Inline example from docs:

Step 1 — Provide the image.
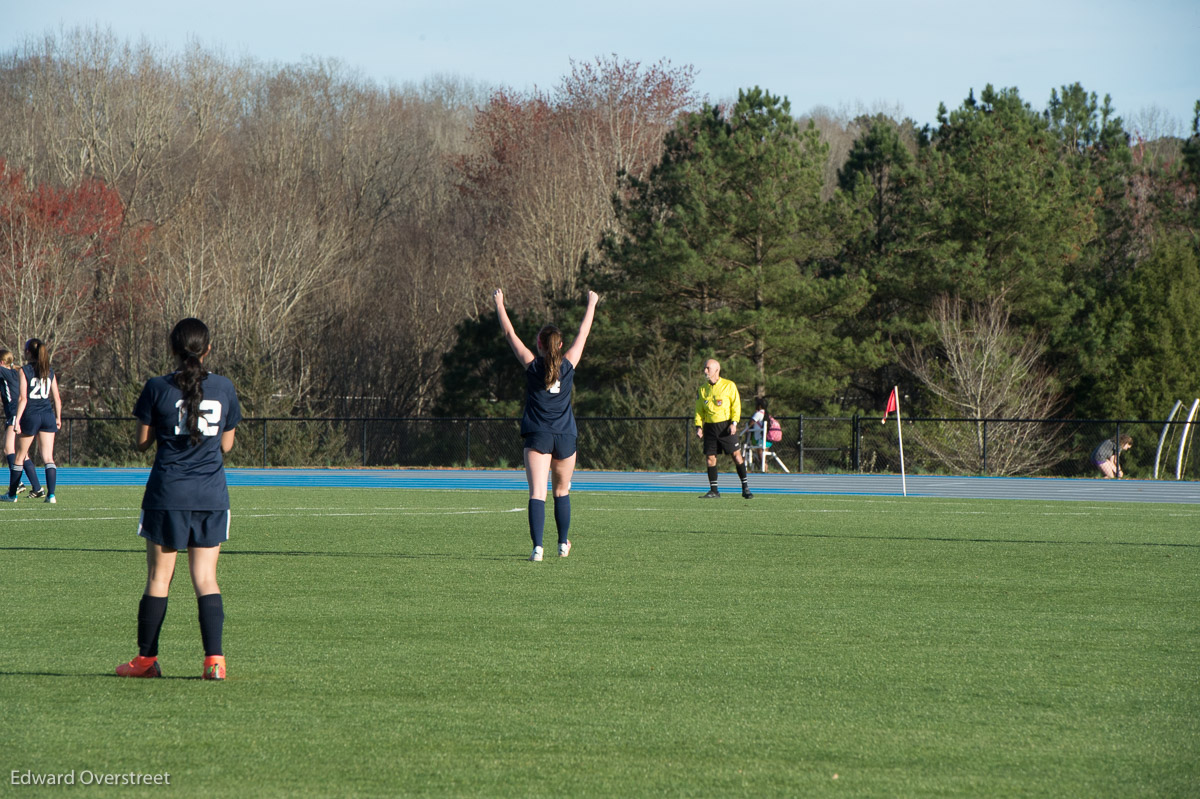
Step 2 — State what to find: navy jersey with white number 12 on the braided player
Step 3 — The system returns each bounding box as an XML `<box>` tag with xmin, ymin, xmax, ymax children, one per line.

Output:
<box><xmin>133</xmin><ymin>374</ymin><xmax>241</xmax><ymax>510</ymax></box>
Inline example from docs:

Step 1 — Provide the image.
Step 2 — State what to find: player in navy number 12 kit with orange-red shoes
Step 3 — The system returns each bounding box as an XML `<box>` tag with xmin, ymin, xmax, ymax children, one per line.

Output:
<box><xmin>116</xmin><ymin>318</ymin><xmax>241</xmax><ymax>680</ymax></box>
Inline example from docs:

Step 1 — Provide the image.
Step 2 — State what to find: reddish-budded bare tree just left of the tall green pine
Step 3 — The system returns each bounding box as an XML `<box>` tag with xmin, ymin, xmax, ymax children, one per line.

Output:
<box><xmin>461</xmin><ymin>56</ymin><xmax>696</xmax><ymax>307</ymax></box>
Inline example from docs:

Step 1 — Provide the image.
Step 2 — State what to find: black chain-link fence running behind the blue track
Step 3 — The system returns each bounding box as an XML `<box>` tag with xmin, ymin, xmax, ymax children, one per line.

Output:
<box><xmin>55</xmin><ymin>416</ymin><xmax>1200</xmax><ymax>480</ymax></box>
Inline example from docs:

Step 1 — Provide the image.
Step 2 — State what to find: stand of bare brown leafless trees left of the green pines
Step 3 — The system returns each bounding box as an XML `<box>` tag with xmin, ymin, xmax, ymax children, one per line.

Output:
<box><xmin>0</xmin><ymin>36</ymin><xmax>695</xmax><ymax>422</ymax></box>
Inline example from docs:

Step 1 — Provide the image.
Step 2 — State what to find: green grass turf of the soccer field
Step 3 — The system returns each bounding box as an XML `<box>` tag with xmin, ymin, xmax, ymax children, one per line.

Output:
<box><xmin>0</xmin><ymin>487</ymin><xmax>1200</xmax><ymax>797</ymax></box>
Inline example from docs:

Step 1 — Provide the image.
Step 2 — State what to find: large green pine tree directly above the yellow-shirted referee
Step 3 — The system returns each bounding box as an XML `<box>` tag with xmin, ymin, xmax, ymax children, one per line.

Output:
<box><xmin>605</xmin><ymin>88</ymin><xmax>868</xmax><ymax>407</ymax></box>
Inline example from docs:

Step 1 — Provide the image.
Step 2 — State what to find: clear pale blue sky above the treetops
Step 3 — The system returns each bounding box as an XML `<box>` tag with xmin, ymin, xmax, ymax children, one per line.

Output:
<box><xmin>0</xmin><ymin>0</ymin><xmax>1200</xmax><ymax>132</ymax></box>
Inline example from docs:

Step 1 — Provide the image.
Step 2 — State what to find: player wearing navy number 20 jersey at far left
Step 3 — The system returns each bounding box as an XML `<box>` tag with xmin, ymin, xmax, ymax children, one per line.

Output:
<box><xmin>0</xmin><ymin>338</ymin><xmax>62</xmax><ymax>505</ymax></box>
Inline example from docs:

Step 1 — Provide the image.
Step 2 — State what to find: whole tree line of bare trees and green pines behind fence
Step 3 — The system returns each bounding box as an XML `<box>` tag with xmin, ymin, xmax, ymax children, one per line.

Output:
<box><xmin>0</xmin><ymin>29</ymin><xmax>1200</xmax><ymax>447</ymax></box>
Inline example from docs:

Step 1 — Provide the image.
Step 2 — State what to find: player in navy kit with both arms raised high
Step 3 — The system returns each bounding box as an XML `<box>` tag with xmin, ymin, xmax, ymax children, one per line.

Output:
<box><xmin>493</xmin><ymin>289</ymin><xmax>600</xmax><ymax>560</ymax></box>
